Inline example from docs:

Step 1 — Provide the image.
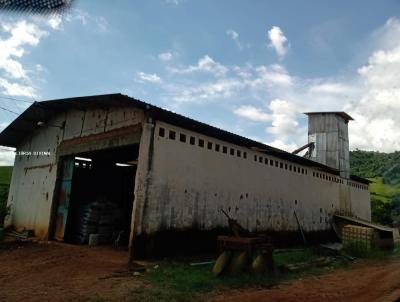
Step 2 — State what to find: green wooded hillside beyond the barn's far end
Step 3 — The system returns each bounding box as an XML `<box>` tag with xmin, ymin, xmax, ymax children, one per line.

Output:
<box><xmin>350</xmin><ymin>150</ymin><xmax>400</xmax><ymax>225</ymax></box>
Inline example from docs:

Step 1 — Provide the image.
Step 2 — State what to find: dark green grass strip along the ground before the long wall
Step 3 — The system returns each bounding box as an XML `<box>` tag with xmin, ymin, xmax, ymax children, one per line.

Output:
<box><xmin>130</xmin><ymin>249</ymin><xmax>338</xmax><ymax>302</ymax></box>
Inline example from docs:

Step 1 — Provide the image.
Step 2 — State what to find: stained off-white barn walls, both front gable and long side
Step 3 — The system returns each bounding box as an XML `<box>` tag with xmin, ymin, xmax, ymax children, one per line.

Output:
<box><xmin>8</xmin><ymin>108</ymin><xmax>371</xmax><ymax>238</ymax></box>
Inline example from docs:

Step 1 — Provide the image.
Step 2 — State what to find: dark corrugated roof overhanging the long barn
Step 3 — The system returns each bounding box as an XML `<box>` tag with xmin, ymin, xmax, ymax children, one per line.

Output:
<box><xmin>0</xmin><ymin>93</ymin><xmax>369</xmax><ymax>183</ymax></box>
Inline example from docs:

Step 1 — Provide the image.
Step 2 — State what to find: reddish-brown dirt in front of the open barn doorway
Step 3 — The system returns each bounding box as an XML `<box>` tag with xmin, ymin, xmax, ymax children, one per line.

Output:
<box><xmin>0</xmin><ymin>242</ymin><xmax>145</xmax><ymax>302</ymax></box>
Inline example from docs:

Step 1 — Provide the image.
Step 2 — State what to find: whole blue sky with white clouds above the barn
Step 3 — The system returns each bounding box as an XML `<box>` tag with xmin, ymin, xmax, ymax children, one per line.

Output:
<box><xmin>0</xmin><ymin>0</ymin><xmax>400</xmax><ymax>165</ymax></box>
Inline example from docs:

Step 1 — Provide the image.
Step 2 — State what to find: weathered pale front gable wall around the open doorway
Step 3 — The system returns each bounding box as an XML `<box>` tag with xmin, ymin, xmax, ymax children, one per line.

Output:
<box><xmin>7</xmin><ymin>108</ymin><xmax>144</xmax><ymax>238</ymax></box>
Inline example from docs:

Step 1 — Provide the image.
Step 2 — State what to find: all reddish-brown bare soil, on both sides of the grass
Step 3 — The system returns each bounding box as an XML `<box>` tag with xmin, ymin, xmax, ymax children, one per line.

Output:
<box><xmin>0</xmin><ymin>242</ymin><xmax>400</xmax><ymax>302</ymax></box>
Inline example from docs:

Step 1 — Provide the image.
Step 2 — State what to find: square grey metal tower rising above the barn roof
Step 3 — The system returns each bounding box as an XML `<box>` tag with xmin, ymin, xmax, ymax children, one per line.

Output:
<box><xmin>306</xmin><ymin>112</ymin><xmax>353</xmax><ymax>179</ymax></box>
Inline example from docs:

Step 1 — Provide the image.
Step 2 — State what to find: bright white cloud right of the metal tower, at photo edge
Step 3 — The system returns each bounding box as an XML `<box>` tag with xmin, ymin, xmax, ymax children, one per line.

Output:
<box><xmin>345</xmin><ymin>18</ymin><xmax>400</xmax><ymax>151</ymax></box>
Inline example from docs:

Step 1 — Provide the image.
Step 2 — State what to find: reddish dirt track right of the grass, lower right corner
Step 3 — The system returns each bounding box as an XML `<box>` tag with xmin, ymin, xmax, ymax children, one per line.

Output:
<box><xmin>210</xmin><ymin>259</ymin><xmax>400</xmax><ymax>302</ymax></box>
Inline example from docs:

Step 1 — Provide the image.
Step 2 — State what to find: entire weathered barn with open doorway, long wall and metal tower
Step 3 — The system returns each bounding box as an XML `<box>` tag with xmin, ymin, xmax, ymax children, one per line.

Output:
<box><xmin>0</xmin><ymin>94</ymin><xmax>371</xmax><ymax>255</ymax></box>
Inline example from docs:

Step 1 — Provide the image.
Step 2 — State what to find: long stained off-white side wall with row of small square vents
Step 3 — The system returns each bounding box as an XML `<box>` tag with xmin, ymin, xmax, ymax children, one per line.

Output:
<box><xmin>136</xmin><ymin>122</ymin><xmax>370</xmax><ymax>235</ymax></box>
